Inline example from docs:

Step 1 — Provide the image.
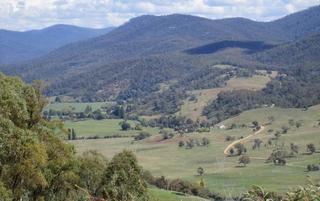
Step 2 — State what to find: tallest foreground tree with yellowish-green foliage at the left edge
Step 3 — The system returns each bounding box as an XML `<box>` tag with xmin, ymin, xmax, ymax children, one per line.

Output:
<box><xmin>0</xmin><ymin>74</ymin><xmax>82</xmax><ymax>200</ymax></box>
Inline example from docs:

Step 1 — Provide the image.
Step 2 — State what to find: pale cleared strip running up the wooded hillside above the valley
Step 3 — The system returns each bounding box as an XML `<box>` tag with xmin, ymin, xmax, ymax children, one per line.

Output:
<box><xmin>177</xmin><ymin>75</ymin><xmax>270</xmax><ymax>120</ymax></box>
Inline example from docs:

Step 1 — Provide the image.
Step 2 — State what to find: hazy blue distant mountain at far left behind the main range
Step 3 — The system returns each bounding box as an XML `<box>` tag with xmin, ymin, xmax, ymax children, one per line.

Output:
<box><xmin>0</xmin><ymin>24</ymin><xmax>113</xmax><ymax>64</ymax></box>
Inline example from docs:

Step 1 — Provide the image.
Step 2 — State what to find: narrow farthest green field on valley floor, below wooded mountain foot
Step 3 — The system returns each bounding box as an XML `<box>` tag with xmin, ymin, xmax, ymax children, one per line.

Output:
<box><xmin>44</xmin><ymin>102</ymin><xmax>110</xmax><ymax>112</ymax></box>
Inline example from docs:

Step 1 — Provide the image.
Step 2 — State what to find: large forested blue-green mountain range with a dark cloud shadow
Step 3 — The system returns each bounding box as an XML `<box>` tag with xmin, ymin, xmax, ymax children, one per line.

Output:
<box><xmin>0</xmin><ymin>6</ymin><xmax>320</xmax><ymax>100</ymax></box>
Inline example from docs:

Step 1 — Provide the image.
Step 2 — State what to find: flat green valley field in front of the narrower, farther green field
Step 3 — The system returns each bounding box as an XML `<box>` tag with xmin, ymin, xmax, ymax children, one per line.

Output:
<box><xmin>65</xmin><ymin>119</ymin><xmax>159</xmax><ymax>137</ymax></box>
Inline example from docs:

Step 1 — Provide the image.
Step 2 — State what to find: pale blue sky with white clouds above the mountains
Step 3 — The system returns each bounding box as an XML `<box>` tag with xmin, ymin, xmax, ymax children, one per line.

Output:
<box><xmin>0</xmin><ymin>0</ymin><xmax>320</xmax><ymax>31</ymax></box>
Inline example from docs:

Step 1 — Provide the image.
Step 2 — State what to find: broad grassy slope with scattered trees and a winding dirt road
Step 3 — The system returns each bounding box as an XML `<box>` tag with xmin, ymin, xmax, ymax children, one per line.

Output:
<box><xmin>72</xmin><ymin>106</ymin><xmax>320</xmax><ymax>197</ymax></box>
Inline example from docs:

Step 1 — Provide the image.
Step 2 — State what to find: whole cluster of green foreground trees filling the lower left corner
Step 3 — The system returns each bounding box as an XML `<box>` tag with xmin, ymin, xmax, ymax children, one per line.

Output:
<box><xmin>0</xmin><ymin>74</ymin><xmax>148</xmax><ymax>201</ymax></box>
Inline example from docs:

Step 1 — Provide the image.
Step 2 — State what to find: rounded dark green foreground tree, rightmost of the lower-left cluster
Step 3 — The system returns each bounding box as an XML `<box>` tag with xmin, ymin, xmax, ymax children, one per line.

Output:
<box><xmin>101</xmin><ymin>151</ymin><xmax>148</xmax><ymax>201</ymax></box>
